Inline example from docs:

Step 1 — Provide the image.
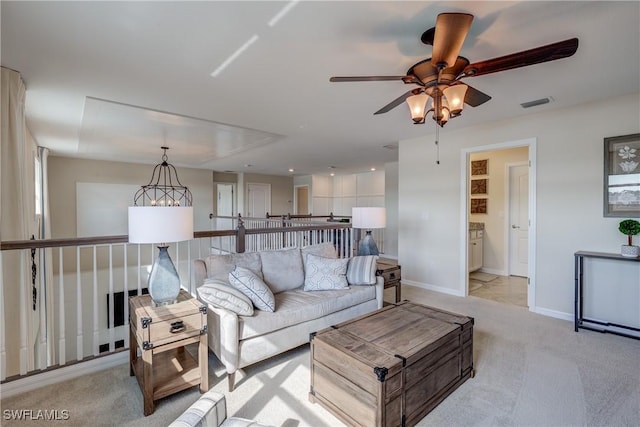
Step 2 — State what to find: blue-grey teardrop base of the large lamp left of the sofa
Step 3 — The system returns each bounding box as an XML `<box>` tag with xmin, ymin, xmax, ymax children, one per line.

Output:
<box><xmin>148</xmin><ymin>246</ymin><xmax>180</xmax><ymax>307</ymax></box>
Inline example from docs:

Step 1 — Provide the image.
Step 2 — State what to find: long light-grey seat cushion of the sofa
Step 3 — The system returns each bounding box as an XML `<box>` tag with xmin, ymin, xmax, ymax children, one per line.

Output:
<box><xmin>238</xmin><ymin>286</ymin><xmax>376</xmax><ymax>340</ymax></box>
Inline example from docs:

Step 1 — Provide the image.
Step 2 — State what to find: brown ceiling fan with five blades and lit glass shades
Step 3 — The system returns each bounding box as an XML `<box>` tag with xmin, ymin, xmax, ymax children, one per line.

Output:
<box><xmin>329</xmin><ymin>13</ymin><xmax>578</xmax><ymax>127</ymax></box>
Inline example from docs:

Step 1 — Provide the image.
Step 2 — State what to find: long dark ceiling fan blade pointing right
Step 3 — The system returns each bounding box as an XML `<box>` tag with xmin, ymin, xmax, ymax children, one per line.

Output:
<box><xmin>463</xmin><ymin>38</ymin><xmax>578</xmax><ymax>77</ymax></box>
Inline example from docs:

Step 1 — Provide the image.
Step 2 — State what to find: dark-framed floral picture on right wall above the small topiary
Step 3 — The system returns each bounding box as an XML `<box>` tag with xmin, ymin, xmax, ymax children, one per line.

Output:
<box><xmin>604</xmin><ymin>133</ymin><xmax>640</xmax><ymax>218</ymax></box>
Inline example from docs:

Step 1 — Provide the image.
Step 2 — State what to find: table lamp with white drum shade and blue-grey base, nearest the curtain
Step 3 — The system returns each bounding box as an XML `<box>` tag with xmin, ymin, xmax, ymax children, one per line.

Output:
<box><xmin>129</xmin><ymin>206</ymin><xmax>193</xmax><ymax>306</ymax></box>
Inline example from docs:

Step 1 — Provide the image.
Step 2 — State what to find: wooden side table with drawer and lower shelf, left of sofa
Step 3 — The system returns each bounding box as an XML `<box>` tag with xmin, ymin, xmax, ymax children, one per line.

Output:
<box><xmin>129</xmin><ymin>290</ymin><xmax>209</xmax><ymax>416</ymax></box>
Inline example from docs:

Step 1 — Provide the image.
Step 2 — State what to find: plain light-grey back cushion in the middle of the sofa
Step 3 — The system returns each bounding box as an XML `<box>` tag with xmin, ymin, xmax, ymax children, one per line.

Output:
<box><xmin>259</xmin><ymin>248</ymin><xmax>304</xmax><ymax>294</ymax></box>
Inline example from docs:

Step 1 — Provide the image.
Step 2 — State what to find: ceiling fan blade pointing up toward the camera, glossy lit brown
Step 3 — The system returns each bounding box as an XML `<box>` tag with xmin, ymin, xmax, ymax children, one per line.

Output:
<box><xmin>431</xmin><ymin>13</ymin><xmax>473</xmax><ymax>67</ymax></box>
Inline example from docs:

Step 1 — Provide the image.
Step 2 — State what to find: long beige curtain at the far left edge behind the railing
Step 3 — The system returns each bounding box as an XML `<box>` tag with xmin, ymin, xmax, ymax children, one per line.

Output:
<box><xmin>0</xmin><ymin>67</ymin><xmax>39</xmax><ymax>379</ymax></box>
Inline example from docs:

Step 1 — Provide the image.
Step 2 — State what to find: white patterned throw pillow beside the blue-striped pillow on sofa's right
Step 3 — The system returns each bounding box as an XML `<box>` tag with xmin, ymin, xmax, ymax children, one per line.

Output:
<box><xmin>304</xmin><ymin>254</ymin><xmax>349</xmax><ymax>291</ymax></box>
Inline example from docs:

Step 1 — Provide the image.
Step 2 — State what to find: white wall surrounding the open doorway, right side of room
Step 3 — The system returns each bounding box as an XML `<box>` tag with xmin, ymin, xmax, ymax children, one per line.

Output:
<box><xmin>398</xmin><ymin>94</ymin><xmax>640</xmax><ymax>317</ymax></box>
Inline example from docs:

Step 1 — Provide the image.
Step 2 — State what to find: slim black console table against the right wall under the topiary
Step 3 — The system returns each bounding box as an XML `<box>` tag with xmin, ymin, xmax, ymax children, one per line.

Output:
<box><xmin>574</xmin><ymin>251</ymin><xmax>640</xmax><ymax>339</ymax></box>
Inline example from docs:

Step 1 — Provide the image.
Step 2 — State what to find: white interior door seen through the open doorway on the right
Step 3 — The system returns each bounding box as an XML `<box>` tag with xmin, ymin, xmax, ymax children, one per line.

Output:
<box><xmin>509</xmin><ymin>164</ymin><xmax>529</xmax><ymax>277</ymax></box>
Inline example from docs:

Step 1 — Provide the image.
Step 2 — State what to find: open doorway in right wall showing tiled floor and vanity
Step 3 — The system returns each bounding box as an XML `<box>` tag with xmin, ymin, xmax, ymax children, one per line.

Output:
<box><xmin>461</xmin><ymin>139</ymin><xmax>536</xmax><ymax>311</ymax></box>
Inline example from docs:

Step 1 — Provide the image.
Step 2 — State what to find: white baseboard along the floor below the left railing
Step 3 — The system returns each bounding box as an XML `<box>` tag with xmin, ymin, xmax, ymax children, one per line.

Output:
<box><xmin>0</xmin><ymin>351</ymin><xmax>129</xmax><ymax>398</ymax></box>
